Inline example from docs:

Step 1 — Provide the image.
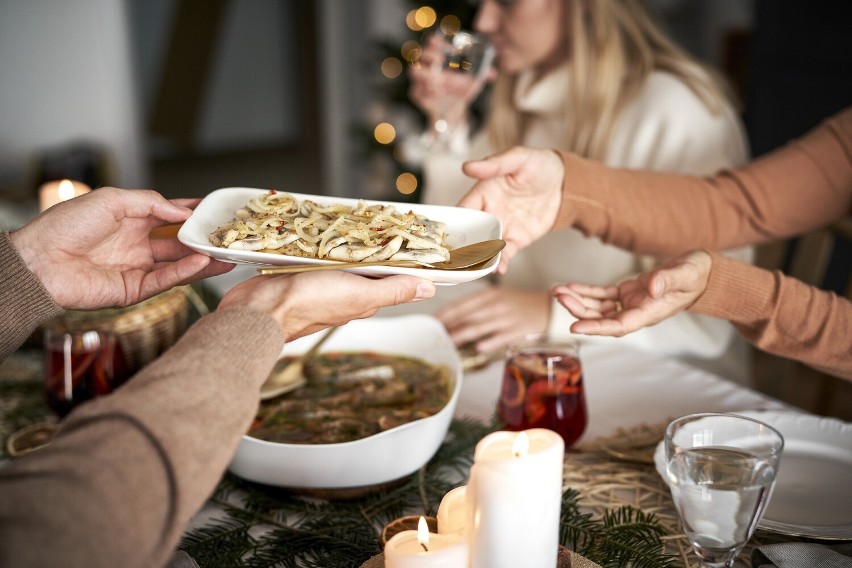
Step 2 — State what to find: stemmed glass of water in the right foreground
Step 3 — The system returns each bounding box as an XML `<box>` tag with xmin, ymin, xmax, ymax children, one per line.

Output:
<box><xmin>665</xmin><ymin>414</ymin><xmax>784</xmax><ymax>568</ymax></box>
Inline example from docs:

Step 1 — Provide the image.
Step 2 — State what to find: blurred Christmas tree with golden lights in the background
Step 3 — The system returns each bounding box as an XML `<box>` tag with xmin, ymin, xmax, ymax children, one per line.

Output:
<box><xmin>355</xmin><ymin>0</ymin><xmax>476</xmax><ymax>203</ymax></box>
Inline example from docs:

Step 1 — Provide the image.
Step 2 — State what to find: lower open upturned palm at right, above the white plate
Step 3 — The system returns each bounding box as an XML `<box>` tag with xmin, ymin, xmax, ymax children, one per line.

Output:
<box><xmin>552</xmin><ymin>251</ymin><xmax>712</xmax><ymax>337</ymax></box>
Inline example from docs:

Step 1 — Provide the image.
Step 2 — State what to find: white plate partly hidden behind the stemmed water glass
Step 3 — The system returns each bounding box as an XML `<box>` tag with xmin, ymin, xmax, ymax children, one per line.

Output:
<box><xmin>654</xmin><ymin>410</ymin><xmax>852</xmax><ymax>540</ymax></box>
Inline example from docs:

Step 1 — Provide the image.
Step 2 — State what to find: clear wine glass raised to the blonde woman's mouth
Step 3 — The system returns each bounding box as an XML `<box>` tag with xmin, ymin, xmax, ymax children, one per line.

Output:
<box><xmin>426</xmin><ymin>30</ymin><xmax>495</xmax><ymax>152</ymax></box>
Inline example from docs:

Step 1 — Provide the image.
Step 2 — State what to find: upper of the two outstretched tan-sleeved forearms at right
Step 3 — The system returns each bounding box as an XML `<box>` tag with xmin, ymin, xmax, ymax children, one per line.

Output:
<box><xmin>557</xmin><ymin>110</ymin><xmax>852</xmax><ymax>256</ymax></box>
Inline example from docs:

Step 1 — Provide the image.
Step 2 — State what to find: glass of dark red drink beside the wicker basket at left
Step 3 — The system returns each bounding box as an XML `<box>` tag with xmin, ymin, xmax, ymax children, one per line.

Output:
<box><xmin>44</xmin><ymin>327</ymin><xmax>128</xmax><ymax>417</ymax></box>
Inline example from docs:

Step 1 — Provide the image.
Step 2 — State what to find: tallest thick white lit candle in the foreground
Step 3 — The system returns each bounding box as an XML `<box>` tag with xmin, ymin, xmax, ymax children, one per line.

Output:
<box><xmin>466</xmin><ymin>428</ymin><xmax>565</xmax><ymax>568</ymax></box>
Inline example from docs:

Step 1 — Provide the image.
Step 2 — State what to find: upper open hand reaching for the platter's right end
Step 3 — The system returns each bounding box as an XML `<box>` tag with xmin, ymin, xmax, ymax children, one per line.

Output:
<box><xmin>459</xmin><ymin>146</ymin><xmax>565</xmax><ymax>274</ymax></box>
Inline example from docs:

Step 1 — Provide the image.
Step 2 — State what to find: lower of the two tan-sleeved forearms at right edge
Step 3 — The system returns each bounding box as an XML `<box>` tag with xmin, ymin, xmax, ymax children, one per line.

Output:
<box><xmin>690</xmin><ymin>254</ymin><xmax>852</xmax><ymax>379</ymax></box>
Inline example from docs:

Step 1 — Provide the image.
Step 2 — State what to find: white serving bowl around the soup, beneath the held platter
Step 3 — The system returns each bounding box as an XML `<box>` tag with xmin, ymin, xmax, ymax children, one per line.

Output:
<box><xmin>229</xmin><ymin>315</ymin><xmax>462</xmax><ymax>489</ymax></box>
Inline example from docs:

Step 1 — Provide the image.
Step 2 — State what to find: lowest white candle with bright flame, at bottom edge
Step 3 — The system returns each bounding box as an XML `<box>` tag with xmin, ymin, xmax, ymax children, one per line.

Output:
<box><xmin>384</xmin><ymin>517</ymin><xmax>467</xmax><ymax>568</ymax></box>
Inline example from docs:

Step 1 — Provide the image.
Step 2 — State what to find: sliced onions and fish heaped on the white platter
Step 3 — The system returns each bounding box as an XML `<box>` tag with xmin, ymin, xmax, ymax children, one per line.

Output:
<box><xmin>209</xmin><ymin>190</ymin><xmax>450</xmax><ymax>263</ymax></box>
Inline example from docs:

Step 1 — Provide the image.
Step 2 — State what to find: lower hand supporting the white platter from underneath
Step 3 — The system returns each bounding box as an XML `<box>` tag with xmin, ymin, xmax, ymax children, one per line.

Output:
<box><xmin>217</xmin><ymin>270</ymin><xmax>435</xmax><ymax>341</ymax></box>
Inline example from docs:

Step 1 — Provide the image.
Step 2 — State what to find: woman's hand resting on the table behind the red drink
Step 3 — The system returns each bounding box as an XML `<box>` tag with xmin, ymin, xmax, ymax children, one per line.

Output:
<box><xmin>435</xmin><ymin>286</ymin><xmax>551</xmax><ymax>353</ymax></box>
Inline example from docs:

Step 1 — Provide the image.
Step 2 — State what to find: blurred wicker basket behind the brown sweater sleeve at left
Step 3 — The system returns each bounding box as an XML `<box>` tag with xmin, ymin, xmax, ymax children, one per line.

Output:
<box><xmin>55</xmin><ymin>286</ymin><xmax>207</xmax><ymax>372</ymax></box>
